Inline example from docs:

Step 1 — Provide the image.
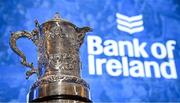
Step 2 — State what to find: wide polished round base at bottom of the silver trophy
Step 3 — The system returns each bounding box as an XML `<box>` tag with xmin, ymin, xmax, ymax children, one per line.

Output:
<box><xmin>28</xmin><ymin>75</ymin><xmax>91</xmax><ymax>103</ymax></box>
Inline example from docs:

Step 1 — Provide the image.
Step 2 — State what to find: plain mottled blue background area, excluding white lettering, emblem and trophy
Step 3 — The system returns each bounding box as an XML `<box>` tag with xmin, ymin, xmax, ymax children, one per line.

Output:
<box><xmin>0</xmin><ymin>0</ymin><xmax>180</xmax><ymax>103</ymax></box>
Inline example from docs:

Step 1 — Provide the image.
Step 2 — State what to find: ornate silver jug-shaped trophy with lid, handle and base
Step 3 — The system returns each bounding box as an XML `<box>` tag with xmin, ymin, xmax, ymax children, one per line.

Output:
<box><xmin>10</xmin><ymin>13</ymin><xmax>91</xmax><ymax>103</ymax></box>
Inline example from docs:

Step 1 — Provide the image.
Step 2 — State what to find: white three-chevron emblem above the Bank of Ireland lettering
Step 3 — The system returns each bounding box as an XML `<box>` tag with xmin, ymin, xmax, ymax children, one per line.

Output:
<box><xmin>116</xmin><ymin>13</ymin><xmax>144</xmax><ymax>34</ymax></box>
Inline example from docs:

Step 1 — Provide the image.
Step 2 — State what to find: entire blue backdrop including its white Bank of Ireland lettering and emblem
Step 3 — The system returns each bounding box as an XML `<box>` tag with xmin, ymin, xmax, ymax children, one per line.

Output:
<box><xmin>0</xmin><ymin>0</ymin><xmax>180</xmax><ymax>102</ymax></box>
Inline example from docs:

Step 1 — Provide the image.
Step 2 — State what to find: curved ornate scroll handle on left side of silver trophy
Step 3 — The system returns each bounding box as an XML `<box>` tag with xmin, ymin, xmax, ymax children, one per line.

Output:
<box><xmin>9</xmin><ymin>30</ymin><xmax>39</xmax><ymax>79</ymax></box>
